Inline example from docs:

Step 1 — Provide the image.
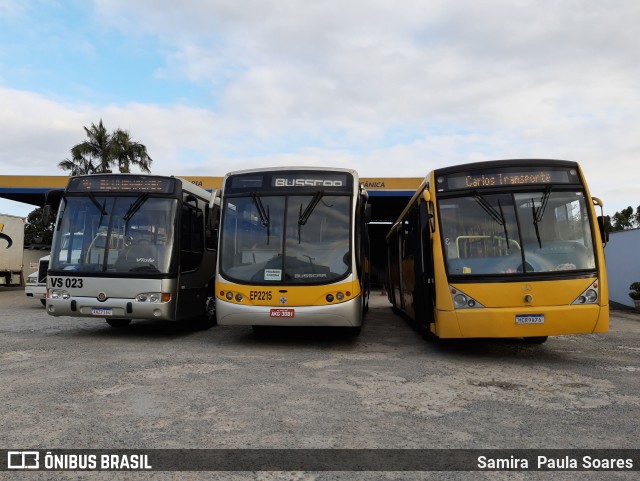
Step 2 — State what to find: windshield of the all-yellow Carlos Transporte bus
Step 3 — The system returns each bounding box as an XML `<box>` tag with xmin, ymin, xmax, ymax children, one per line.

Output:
<box><xmin>439</xmin><ymin>187</ymin><xmax>596</xmax><ymax>276</ymax></box>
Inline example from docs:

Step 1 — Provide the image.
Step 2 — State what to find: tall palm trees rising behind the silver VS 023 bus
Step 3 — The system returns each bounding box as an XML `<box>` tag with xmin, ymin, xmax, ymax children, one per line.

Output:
<box><xmin>58</xmin><ymin>119</ymin><xmax>153</xmax><ymax>175</ymax></box>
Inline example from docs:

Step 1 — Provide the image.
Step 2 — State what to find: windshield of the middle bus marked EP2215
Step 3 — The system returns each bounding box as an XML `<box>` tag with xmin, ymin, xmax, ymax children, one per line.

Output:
<box><xmin>220</xmin><ymin>191</ymin><xmax>351</xmax><ymax>284</ymax></box>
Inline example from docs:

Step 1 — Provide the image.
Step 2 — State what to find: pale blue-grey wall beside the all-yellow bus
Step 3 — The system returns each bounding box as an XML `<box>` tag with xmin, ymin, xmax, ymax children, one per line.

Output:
<box><xmin>604</xmin><ymin>229</ymin><xmax>640</xmax><ymax>307</ymax></box>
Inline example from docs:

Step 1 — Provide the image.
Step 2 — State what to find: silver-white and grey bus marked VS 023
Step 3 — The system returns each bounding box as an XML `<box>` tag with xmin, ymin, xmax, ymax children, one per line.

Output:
<box><xmin>46</xmin><ymin>174</ymin><xmax>219</xmax><ymax>327</ymax></box>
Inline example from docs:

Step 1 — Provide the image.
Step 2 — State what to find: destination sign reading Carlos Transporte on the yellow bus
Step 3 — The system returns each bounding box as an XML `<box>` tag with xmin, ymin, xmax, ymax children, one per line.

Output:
<box><xmin>437</xmin><ymin>168</ymin><xmax>580</xmax><ymax>191</ymax></box>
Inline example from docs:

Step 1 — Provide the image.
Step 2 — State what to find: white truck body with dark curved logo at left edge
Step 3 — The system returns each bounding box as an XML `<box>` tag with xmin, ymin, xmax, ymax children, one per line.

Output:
<box><xmin>0</xmin><ymin>214</ymin><xmax>24</xmax><ymax>287</ymax></box>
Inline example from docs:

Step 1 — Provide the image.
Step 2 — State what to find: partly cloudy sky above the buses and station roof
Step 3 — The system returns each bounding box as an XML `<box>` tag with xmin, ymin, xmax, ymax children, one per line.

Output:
<box><xmin>0</xmin><ymin>0</ymin><xmax>640</xmax><ymax>215</ymax></box>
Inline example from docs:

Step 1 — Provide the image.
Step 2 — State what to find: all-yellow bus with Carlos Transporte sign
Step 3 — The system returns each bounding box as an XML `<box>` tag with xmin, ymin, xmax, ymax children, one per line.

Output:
<box><xmin>386</xmin><ymin>159</ymin><xmax>609</xmax><ymax>343</ymax></box>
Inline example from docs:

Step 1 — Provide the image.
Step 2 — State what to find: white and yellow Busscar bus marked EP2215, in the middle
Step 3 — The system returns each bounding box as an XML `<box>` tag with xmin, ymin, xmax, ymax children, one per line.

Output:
<box><xmin>216</xmin><ymin>167</ymin><xmax>369</xmax><ymax>334</ymax></box>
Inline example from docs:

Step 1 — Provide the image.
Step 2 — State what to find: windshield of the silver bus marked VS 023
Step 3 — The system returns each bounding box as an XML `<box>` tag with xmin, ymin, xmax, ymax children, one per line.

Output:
<box><xmin>50</xmin><ymin>193</ymin><xmax>177</xmax><ymax>275</ymax></box>
